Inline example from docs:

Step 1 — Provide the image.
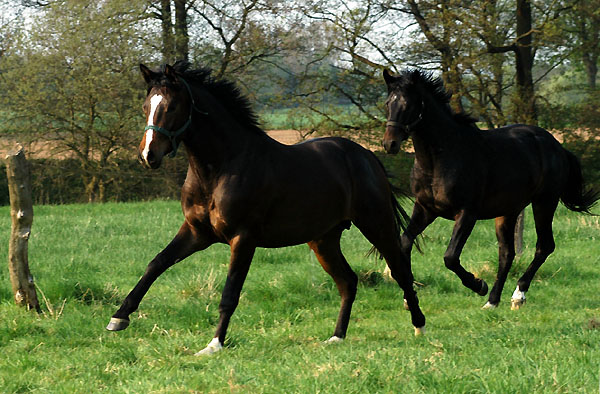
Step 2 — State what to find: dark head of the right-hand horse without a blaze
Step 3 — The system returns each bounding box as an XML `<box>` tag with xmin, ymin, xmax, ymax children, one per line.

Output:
<box><xmin>383</xmin><ymin>69</ymin><xmax>423</xmax><ymax>154</ymax></box>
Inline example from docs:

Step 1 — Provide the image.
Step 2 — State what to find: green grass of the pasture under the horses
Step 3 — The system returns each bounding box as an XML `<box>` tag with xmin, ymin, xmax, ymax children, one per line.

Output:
<box><xmin>0</xmin><ymin>201</ymin><xmax>600</xmax><ymax>393</ymax></box>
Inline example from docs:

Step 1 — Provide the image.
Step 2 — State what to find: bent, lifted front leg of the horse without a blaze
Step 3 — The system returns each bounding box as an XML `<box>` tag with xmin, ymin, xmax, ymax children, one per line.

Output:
<box><xmin>444</xmin><ymin>210</ymin><xmax>488</xmax><ymax>296</ymax></box>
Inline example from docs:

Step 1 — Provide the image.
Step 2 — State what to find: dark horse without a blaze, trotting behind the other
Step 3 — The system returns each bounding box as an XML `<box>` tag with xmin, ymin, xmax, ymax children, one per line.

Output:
<box><xmin>383</xmin><ymin>70</ymin><xmax>599</xmax><ymax>309</ymax></box>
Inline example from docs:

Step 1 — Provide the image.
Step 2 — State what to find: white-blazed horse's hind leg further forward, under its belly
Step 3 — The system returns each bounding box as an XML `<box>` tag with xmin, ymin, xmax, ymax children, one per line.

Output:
<box><xmin>308</xmin><ymin>226</ymin><xmax>358</xmax><ymax>342</ymax></box>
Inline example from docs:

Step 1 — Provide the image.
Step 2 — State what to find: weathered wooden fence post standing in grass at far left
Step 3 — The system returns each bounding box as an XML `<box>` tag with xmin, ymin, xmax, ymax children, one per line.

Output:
<box><xmin>6</xmin><ymin>145</ymin><xmax>40</xmax><ymax>312</ymax></box>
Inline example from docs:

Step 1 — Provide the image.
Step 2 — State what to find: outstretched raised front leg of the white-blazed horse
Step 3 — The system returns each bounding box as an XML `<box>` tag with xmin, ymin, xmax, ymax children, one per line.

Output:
<box><xmin>106</xmin><ymin>222</ymin><xmax>214</xmax><ymax>331</ymax></box>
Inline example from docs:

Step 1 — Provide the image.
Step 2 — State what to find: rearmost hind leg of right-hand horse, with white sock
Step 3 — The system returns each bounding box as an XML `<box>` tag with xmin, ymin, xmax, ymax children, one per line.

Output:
<box><xmin>511</xmin><ymin>200</ymin><xmax>558</xmax><ymax>310</ymax></box>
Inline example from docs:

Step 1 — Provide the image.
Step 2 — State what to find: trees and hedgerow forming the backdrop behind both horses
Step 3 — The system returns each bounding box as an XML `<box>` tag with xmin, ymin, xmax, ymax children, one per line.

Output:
<box><xmin>0</xmin><ymin>0</ymin><xmax>600</xmax><ymax>204</ymax></box>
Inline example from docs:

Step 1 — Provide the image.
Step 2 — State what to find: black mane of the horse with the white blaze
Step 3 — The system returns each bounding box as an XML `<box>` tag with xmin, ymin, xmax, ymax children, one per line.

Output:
<box><xmin>151</xmin><ymin>61</ymin><xmax>265</xmax><ymax>134</ymax></box>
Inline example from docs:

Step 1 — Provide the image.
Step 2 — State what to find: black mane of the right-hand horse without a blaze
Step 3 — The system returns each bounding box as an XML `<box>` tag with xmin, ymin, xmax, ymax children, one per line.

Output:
<box><xmin>396</xmin><ymin>69</ymin><xmax>477</xmax><ymax>126</ymax></box>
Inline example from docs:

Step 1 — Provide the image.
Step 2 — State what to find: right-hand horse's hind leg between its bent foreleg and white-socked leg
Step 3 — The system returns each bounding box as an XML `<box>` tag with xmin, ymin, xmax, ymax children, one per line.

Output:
<box><xmin>483</xmin><ymin>215</ymin><xmax>518</xmax><ymax>309</ymax></box>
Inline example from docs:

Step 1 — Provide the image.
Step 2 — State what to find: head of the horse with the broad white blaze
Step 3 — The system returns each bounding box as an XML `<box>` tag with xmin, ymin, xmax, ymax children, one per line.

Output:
<box><xmin>138</xmin><ymin>64</ymin><xmax>194</xmax><ymax>169</ymax></box>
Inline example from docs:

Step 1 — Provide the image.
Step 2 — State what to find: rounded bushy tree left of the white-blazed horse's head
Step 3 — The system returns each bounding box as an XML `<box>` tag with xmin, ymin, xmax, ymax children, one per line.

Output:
<box><xmin>0</xmin><ymin>0</ymin><xmax>148</xmax><ymax>201</ymax></box>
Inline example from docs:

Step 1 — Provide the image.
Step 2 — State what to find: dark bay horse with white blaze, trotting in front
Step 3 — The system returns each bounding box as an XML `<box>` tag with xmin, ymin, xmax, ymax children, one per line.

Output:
<box><xmin>107</xmin><ymin>62</ymin><xmax>425</xmax><ymax>354</ymax></box>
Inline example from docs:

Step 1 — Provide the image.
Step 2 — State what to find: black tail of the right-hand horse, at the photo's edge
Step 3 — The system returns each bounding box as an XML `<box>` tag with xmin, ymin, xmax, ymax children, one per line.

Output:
<box><xmin>560</xmin><ymin>151</ymin><xmax>600</xmax><ymax>215</ymax></box>
